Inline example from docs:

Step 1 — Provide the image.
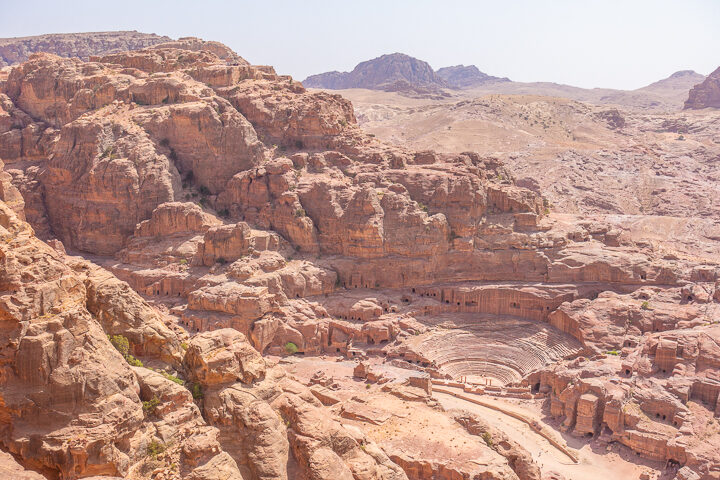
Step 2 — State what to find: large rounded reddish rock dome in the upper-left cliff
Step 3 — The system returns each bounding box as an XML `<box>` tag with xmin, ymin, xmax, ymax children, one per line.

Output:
<box><xmin>40</xmin><ymin>115</ymin><xmax>180</xmax><ymax>254</ymax></box>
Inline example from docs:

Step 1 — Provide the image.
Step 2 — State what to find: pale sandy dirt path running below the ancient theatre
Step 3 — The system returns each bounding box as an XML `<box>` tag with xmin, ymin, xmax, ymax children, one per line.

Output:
<box><xmin>433</xmin><ymin>389</ymin><xmax>660</xmax><ymax>480</ymax></box>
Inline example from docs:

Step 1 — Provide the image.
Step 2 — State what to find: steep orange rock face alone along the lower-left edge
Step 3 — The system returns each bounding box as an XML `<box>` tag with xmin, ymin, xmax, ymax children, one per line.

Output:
<box><xmin>1</xmin><ymin>204</ymin><xmax>143</xmax><ymax>478</ymax></box>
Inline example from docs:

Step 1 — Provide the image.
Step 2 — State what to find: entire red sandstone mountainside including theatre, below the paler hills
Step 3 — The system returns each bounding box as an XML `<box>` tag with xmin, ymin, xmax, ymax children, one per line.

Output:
<box><xmin>0</xmin><ymin>38</ymin><xmax>720</xmax><ymax>480</ymax></box>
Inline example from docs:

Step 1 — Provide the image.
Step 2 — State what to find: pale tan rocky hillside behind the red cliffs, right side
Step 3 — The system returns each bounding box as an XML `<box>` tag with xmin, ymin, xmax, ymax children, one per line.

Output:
<box><xmin>343</xmin><ymin>91</ymin><xmax>720</xmax><ymax>223</ymax></box>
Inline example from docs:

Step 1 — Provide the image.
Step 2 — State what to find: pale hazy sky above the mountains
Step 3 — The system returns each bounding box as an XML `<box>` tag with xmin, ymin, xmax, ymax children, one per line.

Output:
<box><xmin>0</xmin><ymin>0</ymin><xmax>720</xmax><ymax>89</ymax></box>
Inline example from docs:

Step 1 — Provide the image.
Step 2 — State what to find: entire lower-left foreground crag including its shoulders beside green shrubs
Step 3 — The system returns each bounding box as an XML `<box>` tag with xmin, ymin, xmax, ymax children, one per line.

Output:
<box><xmin>0</xmin><ymin>203</ymin><xmax>242</xmax><ymax>480</ymax></box>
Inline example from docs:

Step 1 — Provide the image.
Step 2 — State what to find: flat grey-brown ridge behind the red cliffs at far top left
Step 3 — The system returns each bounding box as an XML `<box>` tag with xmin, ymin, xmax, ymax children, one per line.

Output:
<box><xmin>0</xmin><ymin>31</ymin><xmax>170</xmax><ymax>67</ymax></box>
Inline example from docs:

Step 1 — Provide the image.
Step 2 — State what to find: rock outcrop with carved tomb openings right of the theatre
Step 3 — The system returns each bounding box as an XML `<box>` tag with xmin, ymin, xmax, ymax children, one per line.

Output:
<box><xmin>527</xmin><ymin>286</ymin><xmax>720</xmax><ymax>478</ymax></box>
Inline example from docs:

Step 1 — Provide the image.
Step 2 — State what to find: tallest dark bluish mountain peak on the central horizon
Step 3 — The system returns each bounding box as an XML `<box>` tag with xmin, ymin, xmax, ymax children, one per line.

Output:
<box><xmin>302</xmin><ymin>53</ymin><xmax>449</xmax><ymax>92</ymax></box>
